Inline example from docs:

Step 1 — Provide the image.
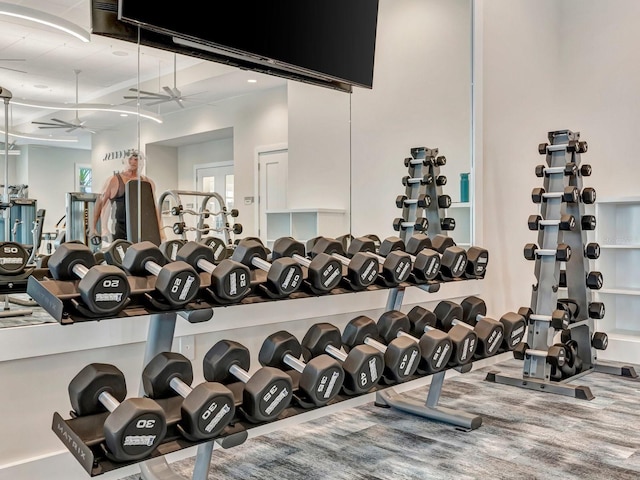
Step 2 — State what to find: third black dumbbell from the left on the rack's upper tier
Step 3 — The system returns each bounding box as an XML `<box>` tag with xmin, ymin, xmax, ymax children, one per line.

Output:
<box><xmin>176</xmin><ymin>242</ymin><xmax>251</xmax><ymax>303</ymax></box>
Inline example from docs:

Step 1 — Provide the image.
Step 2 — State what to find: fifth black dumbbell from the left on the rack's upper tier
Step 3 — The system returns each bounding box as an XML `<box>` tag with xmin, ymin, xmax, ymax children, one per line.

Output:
<box><xmin>271</xmin><ymin>237</ymin><xmax>342</xmax><ymax>293</ymax></box>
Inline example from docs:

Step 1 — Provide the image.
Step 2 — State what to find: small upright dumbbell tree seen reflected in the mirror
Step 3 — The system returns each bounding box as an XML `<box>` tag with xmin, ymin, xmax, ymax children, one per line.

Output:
<box><xmin>397</xmin><ymin>147</ymin><xmax>455</xmax><ymax>242</ymax></box>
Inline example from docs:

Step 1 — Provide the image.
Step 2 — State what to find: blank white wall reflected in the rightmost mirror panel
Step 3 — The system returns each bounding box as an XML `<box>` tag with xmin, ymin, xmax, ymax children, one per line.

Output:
<box><xmin>351</xmin><ymin>0</ymin><xmax>471</xmax><ymax>238</ymax></box>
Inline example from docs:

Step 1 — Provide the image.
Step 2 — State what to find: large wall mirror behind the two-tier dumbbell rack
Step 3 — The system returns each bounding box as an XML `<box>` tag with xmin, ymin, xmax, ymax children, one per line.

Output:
<box><xmin>0</xmin><ymin>0</ymin><xmax>472</xmax><ymax>326</ymax></box>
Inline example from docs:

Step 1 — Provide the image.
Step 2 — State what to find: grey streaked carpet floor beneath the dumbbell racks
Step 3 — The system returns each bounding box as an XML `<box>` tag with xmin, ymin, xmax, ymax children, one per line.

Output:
<box><xmin>119</xmin><ymin>359</ymin><xmax>640</xmax><ymax>480</ymax></box>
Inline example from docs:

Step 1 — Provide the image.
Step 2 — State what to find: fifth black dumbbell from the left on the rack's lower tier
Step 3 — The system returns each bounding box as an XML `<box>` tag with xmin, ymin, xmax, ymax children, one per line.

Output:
<box><xmin>302</xmin><ymin>322</ymin><xmax>384</xmax><ymax>395</ymax></box>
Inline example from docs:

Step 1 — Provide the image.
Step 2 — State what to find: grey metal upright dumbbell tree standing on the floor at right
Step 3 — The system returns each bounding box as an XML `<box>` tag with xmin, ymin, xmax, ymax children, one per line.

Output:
<box><xmin>487</xmin><ymin>130</ymin><xmax>636</xmax><ymax>400</ymax></box>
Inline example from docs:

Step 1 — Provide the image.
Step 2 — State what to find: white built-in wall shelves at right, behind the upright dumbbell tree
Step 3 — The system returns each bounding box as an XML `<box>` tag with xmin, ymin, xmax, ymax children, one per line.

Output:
<box><xmin>594</xmin><ymin>196</ymin><xmax>640</xmax><ymax>362</ymax></box>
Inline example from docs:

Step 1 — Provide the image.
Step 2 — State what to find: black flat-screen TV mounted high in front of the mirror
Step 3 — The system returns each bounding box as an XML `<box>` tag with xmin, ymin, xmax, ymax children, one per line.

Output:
<box><xmin>118</xmin><ymin>0</ymin><xmax>378</xmax><ymax>91</ymax></box>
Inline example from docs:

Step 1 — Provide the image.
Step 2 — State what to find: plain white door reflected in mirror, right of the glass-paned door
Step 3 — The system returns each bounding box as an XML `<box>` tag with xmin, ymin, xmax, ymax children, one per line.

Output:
<box><xmin>258</xmin><ymin>149</ymin><xmax>289</xmax><ymax>245</ymax></box>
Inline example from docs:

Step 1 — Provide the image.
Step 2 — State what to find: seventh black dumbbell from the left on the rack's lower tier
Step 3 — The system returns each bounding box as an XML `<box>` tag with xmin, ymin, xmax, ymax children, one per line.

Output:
<box><xmin>377</xmin><ymin>310</ymin><xmax>453</xmax><ymax>375</ymax></box>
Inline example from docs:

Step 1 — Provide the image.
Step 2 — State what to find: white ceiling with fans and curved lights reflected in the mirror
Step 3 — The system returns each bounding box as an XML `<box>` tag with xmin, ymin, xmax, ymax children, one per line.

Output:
<box><xmin>0</xmin><ymin>0</ymin><xmax>285</xmax><ymax>148</ymax></box>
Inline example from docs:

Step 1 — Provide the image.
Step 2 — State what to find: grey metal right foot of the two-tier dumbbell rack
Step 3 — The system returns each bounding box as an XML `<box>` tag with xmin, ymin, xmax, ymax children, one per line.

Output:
<box><xmin>375</xmin><ymin>371</ymin><xmax>482</xmax><ymax>431</ymax></box>
